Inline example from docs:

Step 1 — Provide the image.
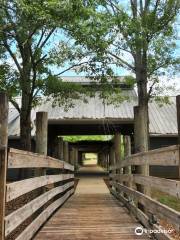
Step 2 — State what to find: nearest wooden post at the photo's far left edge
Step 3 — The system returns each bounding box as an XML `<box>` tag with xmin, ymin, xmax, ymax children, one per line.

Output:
<box><xmin>0</xmin><ymin>93</ymin><xmax>8</xmax><ymax>240</ymax></box>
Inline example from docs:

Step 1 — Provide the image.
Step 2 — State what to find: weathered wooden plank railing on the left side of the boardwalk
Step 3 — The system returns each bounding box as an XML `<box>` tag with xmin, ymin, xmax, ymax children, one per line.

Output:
<box><xmin>0</xmin><ymin>148</ymin><xmax>74</xmax><ymax>240</ymax></box>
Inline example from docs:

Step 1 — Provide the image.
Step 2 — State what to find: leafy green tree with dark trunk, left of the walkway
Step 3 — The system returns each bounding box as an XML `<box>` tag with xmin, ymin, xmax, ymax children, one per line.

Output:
<box><xmin>0</xmin><ymin>0</ymin><xmax>92</xmax><ymax>150</ymax></box>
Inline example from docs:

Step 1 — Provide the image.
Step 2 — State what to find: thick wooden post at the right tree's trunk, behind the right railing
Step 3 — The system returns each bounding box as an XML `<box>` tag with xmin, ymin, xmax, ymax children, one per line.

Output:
<box><xmin>134</xmin><ymin>106</ymin><xmax>150</xmax><ymax>195</ymax></box>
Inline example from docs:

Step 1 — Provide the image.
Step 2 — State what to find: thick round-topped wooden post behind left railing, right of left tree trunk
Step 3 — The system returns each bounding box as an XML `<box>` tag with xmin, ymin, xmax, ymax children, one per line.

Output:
<box><xmin>35</xmin><ymin>112</ymin><xmax>48</xmax><ymax>176</ymax></box>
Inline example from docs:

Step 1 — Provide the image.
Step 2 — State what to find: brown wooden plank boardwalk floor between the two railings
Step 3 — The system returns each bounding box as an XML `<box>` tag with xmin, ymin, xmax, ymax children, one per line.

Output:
<box><xmin>34</xmin><ymin>172</ymin><xmax>148</xmax><ymax>240</ymax></box>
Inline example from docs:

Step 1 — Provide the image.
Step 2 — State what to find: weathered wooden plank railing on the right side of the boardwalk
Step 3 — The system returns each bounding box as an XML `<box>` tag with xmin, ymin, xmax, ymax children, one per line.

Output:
<box><xmin>110</xmin><ymin>145</ymin><xmax>180</xmax><ymax>240</ymax></box>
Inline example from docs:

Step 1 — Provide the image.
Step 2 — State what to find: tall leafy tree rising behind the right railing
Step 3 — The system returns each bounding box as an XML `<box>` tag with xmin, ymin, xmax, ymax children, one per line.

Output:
<box><xmin>67</xmin><ymin>0</ymin><xmax>180</xmax><ymax>151</ymax></box>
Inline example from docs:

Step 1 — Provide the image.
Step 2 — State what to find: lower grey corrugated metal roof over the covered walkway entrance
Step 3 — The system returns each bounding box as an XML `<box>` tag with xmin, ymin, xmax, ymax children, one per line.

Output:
<box><xmin>9</xmin><ymin>90</ymin><xmax>177</xmax><ymax>137</ymax></box>
